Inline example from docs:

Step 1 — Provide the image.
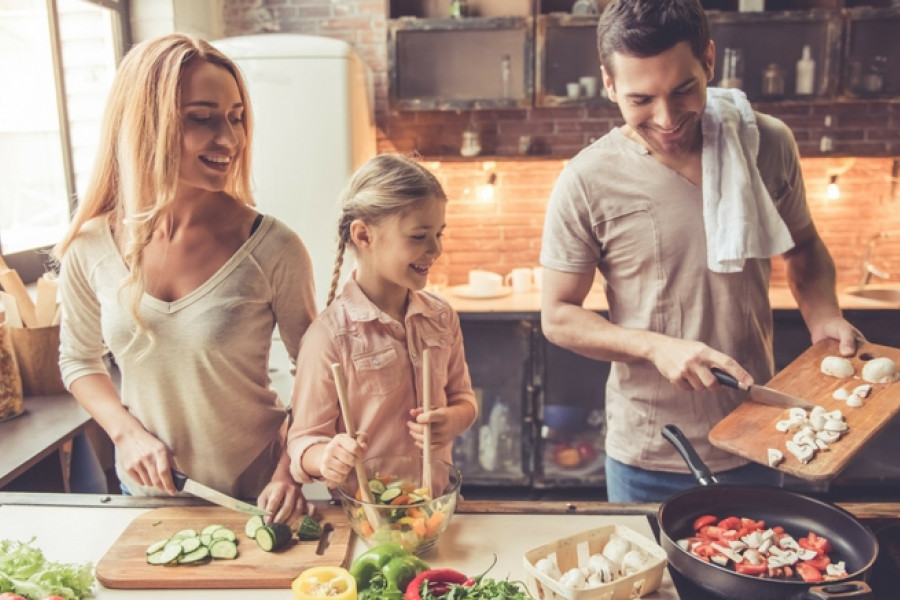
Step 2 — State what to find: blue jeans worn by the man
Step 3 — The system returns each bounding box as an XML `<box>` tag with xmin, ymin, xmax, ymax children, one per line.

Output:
<box><xmin>606</xmin><ymin>456</ymin><xmax>781</xmax><ymax>502</ymax></box>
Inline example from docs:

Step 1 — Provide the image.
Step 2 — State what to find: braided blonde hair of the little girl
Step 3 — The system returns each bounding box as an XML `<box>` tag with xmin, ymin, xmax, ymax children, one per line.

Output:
<box><xmin>326</xmin><ymin>154</ymin><xmax>447</xmax><ymax>304</ymax></box>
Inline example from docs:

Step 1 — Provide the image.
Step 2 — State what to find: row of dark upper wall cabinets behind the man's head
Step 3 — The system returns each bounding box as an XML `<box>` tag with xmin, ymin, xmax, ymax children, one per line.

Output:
<box><xmin>389</xmin><ymin>0</ymin><xmax>900</xmax><ymax>110</ymax></box>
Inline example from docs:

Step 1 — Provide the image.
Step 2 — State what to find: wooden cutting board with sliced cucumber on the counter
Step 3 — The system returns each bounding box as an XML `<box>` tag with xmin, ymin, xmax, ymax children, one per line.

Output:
<box><xmin>95</xmin><ymin>505</ymin><xmax>352</xmax><ymax>589</ymax></box>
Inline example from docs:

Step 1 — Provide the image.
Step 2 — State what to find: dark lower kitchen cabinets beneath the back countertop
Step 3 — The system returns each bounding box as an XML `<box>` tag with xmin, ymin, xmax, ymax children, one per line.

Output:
<box><xmin>454</xmin><ymin>309</ymin><xmax>900</xmax><ymax>500</ymax></box>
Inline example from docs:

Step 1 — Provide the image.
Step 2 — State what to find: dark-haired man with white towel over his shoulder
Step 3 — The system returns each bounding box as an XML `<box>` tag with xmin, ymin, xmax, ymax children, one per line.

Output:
<box><xmin>541</xmin><ymin>0</ymin><xmax>859</xmax><ymax>502</ymax></box>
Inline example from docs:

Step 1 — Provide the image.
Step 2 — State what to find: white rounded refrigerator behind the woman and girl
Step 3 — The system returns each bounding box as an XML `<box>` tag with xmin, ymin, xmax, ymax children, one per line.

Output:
<box><xmin>212</xmin><ymin>33</ymin><xmax>375</xmax><ymax>412</ymax></box>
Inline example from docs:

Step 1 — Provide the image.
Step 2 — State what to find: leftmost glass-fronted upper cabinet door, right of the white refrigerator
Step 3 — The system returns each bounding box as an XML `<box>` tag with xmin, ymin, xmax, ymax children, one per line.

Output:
<box><xmin>388</xmin><ymin>17</ymin><xmax>534</xmax><ymax>110</ymax></box>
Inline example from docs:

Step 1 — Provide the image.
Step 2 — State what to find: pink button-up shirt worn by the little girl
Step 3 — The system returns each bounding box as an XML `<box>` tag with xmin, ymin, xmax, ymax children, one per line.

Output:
<box><xmin>288</xmin><ymin>278</ymin><xmax>478</xmax><ymax>483</ymax></box>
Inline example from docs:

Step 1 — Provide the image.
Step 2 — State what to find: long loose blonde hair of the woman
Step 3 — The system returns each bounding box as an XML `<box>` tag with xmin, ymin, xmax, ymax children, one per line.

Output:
<box><xmin>54</xmin><ymin>33</ymin><xmax>254</xmax><ymax>339</ymax></box>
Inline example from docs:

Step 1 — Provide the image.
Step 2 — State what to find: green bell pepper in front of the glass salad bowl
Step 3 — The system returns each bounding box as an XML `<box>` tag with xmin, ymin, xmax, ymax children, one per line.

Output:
<box><xmin>350</xmin><ymin>544</ymin><xmax>429</xmax><ymax>600</ymax></box>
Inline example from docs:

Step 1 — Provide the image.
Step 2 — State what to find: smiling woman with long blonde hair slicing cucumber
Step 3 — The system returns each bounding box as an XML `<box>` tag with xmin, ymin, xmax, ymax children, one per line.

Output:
<box><xmin>56</xmin><ymin>34</ymin><xmax>316</xmax><ymax>521</ymax></box>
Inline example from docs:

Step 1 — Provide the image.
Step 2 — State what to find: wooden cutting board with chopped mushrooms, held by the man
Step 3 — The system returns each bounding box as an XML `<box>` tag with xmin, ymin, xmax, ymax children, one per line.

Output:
<box><xmin>709</xmin><ymin>340</ymin><xmax>900</xmax><ymax>481</ymax></box>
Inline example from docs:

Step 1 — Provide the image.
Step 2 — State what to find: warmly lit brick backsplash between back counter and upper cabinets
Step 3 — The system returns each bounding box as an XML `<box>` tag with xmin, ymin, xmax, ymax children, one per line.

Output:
<box><xmin>427</xmin><ymin>158</ymin><xmax>900</xmax><ymax>287</ymax></box>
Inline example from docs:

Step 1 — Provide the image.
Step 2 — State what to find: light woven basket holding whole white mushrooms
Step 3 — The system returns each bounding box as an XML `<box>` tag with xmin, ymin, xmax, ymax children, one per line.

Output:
<box><xmin>525</xmin><ymin>525</ymin><xmax>667</xmax><ymax>600</ymax></box>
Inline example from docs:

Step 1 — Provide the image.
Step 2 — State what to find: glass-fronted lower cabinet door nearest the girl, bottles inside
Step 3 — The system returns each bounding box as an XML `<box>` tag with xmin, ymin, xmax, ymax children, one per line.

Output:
<box><xmin>453</xmin><ymin>320</ymin><xmax>534</xmax><ymax>486</ymax></box>
